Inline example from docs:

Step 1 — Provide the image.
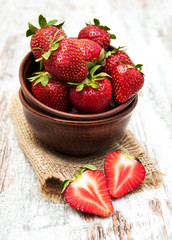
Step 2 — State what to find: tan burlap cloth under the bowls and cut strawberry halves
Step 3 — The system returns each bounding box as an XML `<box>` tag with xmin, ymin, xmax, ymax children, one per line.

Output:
<box><xmin>9</xmin><ymin>94</ymin><xmax>162</xmax><ymax>202</ymax></box>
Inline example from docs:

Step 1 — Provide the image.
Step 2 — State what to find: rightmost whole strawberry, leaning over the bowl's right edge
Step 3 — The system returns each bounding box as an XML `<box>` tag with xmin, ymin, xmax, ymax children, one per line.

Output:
<box><xmin>111</xmin><ymin>63</ymin><xmax>144</xmax><ymax>103</ymax></box>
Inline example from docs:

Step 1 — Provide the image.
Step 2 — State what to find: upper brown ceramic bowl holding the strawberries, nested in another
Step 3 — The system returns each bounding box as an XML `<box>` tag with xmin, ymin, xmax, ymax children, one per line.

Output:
<box><xmin>19</xmin><ymin>52</ymin><xmax>136</xmax><ymax>120</ymax></box>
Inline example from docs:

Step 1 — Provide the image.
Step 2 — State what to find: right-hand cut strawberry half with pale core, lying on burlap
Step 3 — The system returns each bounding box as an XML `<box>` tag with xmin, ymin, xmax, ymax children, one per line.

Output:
<box><xmin>104</xmin><ymin>151</ymin><xmax>145</xmax><ymax>198</ymax></box>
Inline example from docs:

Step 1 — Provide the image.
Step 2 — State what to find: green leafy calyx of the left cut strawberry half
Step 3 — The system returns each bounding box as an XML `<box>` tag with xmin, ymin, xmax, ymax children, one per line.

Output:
<box><xmin>61</xmin><ymin>164</ymin><xmax>97</xmax><ymax>193</ymax></box>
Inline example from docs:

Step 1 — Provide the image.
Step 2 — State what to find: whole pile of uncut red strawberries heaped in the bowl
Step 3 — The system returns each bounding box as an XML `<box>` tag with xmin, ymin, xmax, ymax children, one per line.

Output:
<box><xmin>26</xmin><ymin>15</ymin><xmax>144</xmax><ymax>113</ymax></box>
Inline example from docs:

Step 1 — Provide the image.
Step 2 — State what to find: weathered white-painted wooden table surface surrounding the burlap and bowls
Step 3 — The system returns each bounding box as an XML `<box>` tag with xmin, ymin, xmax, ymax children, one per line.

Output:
<box><xmin>0</xmin><ymin>0</ymin><xmax>172</xmax><ymax>240</ymax></box>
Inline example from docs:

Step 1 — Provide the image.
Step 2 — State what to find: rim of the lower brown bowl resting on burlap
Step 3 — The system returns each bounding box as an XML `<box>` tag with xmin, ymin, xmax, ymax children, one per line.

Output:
<box><xmin>19</xmin><ymin>87</ymin><xmax>138</xmax><ymax>126</ymax></box>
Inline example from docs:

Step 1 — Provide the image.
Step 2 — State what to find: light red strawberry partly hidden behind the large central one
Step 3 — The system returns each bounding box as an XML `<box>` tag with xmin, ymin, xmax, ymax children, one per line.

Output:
<box><xmin>69</xmin><ymin>38</ymin><xmax>105</xmax><ymax>67</ymax></box>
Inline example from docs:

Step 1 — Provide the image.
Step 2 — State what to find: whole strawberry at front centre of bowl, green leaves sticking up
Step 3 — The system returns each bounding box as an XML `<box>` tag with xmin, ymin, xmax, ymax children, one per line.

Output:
<box><xmin>69</xmin><ymin>65</ymin><xmax>112</xmax><ymax>113</ymax></box>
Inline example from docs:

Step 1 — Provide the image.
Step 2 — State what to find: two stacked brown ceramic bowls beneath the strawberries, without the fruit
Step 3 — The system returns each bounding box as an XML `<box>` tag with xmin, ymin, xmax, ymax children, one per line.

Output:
<box><xmin>19</xmin><ymin>52</ymin><xmax>138</xmax><ymax>155</ymax></box>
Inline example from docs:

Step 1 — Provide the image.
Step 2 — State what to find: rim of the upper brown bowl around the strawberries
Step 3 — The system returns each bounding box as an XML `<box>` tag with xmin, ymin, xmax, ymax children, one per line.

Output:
<box><xmin>19</xmin><ymin>51</ymin><xmax>137</xmax><ymax>120</ymax></box>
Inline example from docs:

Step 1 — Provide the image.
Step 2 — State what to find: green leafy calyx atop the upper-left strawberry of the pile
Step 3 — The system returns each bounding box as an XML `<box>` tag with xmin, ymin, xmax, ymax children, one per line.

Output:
<box><xmin>26</xmin><ymin>14</ymin><xmax>64</xmax><ymax>37</ymax></box>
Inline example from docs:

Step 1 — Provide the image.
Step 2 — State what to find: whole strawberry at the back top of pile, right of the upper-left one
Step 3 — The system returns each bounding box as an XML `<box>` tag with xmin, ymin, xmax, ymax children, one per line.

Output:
<box><xmin>78</xmin><ymin>18</ymin><xmax>116</xmax><ymax>50</ymax></box>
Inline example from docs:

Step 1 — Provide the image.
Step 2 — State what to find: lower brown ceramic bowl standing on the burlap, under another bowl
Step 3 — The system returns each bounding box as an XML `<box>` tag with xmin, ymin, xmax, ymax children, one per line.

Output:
<box><xmin>19</xmin><ymin>88</ymin><xmax>138</xmax><ymax>155</ymax></box>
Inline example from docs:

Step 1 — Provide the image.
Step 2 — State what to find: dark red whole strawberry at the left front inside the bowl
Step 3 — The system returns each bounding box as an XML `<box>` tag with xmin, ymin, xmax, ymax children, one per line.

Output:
<box><xmin>29</xmin><ymin>71</ymin><xmax>68</xmax><ymax>111</ymax></box>
